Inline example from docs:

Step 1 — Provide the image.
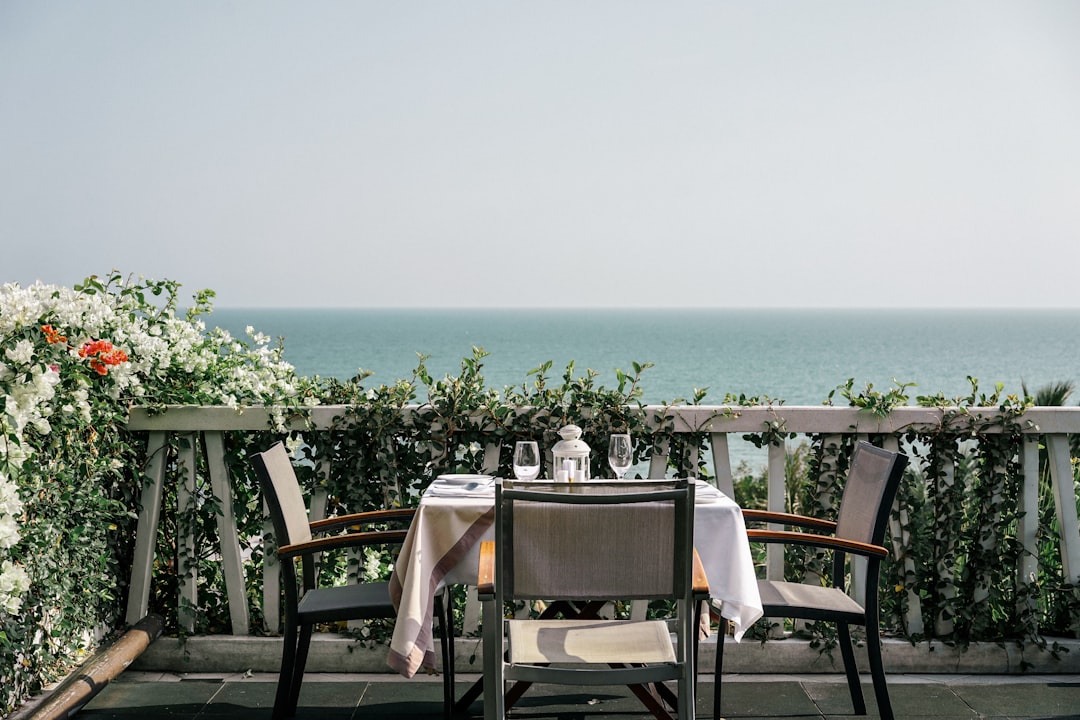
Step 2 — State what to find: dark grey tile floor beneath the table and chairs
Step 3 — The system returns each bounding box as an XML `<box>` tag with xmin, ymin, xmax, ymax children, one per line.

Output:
<box><xmin>31</xmin><ymin>673</ymin><xmax>1080</xmax><ymax>720</ymax></box>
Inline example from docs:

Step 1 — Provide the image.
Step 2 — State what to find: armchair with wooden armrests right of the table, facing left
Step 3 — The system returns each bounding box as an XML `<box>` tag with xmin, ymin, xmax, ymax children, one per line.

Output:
<box><xmin>713</xmin><ymin>441</ymin><xmax>907</xmax><ymax>720</ymax></box>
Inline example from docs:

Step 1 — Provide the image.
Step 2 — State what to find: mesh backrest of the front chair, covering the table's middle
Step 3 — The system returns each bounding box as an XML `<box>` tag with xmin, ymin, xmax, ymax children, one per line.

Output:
<box><xmin>496</xmin><ymin>481</ymin><xmax>693</xmax><ymax>600</ymax></box>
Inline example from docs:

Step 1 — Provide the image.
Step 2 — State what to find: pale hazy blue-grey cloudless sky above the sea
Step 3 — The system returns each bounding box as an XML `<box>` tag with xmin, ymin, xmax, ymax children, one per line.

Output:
<box><xmin>0</xmin><ymin>0</ymin><xmax>1080</xmax><ymax>308</ymax></box>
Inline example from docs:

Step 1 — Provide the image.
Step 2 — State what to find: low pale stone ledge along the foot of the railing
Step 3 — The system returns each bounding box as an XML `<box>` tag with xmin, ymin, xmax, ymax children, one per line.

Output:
<box><xmin>131</xmin><ymin>634</ymin><xmax>1080</xmax><ymax>675</ymax></box>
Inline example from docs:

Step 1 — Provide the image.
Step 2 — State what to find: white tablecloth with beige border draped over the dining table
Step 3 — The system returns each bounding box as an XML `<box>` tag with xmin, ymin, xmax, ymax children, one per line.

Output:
<box><xmin>387</xmin><ymin>481</ymin><xmax>761</xmax><ymax>678</ymax></box>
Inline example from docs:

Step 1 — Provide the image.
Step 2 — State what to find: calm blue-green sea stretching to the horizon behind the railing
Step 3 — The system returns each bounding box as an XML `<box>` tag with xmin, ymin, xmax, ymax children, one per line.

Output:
<box><xmin>205</xmin><ymin>309</ymin><xmax>1080</xmax><ymax>470</ymax></box>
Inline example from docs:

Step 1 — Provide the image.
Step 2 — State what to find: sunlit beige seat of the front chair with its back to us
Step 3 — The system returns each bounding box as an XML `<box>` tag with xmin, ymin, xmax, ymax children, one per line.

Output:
<box><xmin>508</xmin><ymin>620</ymin><xmax>676</xmax><ymax>664</ymax></box>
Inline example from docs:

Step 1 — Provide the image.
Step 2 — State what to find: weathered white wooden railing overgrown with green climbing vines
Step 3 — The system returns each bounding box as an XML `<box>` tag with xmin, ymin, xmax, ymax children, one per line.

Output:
<box><xmin>127</xmin><ymin>406</ymin><xmax>1080</xmax><ymax>635</ymax></box>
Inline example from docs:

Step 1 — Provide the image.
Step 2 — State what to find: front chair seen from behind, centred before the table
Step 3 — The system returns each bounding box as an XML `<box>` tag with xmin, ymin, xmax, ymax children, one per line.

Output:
<box><xmin>477</xmin><ymin>480</ymin><xmax>708</xmax><ymax>720</ymax></box>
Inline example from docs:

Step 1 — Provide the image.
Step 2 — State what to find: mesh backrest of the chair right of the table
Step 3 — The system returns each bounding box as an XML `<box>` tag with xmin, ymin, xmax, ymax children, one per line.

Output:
<box><xmin>836</xmin><ymin>441</ymin><xmax>907</xmax><ymax>545</ymax></box>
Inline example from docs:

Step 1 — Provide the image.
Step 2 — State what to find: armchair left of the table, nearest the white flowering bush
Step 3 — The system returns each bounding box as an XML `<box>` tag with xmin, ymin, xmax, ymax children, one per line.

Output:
<box><xmin>251</xmin><ymin>443</ymin><xmax>454</xmax><ymax>720</ymax></box>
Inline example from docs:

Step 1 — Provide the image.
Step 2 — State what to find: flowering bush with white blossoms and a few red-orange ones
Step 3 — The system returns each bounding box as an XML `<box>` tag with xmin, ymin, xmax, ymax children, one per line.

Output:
<box><xmin>0</xmin><ymin>273</ymin><xmax>316</xmax><ymax>715</ymax></box>
